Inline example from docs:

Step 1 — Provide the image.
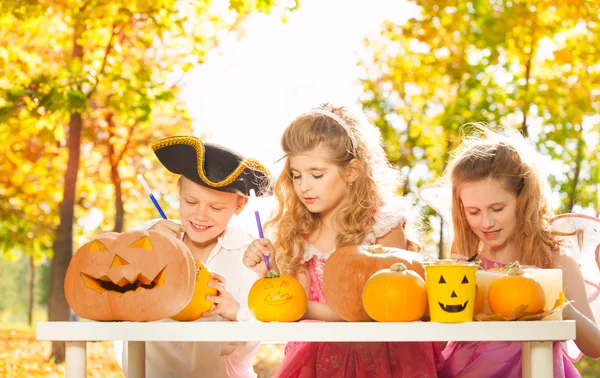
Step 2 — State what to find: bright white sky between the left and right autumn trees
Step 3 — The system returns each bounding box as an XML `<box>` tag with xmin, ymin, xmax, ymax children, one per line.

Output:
<box><xmin>184</xmin><ymin>0</ymin><xmax>416</xmax><ymax>234</ymax></box>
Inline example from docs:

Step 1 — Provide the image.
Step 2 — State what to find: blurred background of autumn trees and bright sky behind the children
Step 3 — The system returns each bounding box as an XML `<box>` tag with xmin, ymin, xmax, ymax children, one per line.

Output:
<box><xmin>0</xmin><ymin>0</ymin><xmax>600</xmax><ymax>377</ymax></box>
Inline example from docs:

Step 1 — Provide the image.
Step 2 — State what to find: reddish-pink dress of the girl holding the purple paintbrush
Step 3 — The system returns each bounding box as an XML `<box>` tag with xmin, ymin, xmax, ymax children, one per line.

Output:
<box><xmin>275</xmin><ymin>256</ymin><xmax>441</xmax><ymax>378</ymax></box>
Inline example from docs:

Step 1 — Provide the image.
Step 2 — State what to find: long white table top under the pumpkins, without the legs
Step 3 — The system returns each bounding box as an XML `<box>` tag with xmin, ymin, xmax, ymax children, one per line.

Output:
<box><xmin>36</xmin><ymin>320</ymin><xmax>575</xmax><ymax>342</ymax></box>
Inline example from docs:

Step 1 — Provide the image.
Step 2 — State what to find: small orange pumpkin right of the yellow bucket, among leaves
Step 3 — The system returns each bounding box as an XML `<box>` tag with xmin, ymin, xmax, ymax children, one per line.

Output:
<box><xmin>488</xmin><ymin>262</ymin><xmax>546</xmax><ymax>318</ymax></box>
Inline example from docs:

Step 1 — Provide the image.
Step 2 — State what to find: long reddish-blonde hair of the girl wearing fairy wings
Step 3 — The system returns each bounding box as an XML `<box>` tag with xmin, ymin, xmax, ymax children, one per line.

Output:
<box><xmin>446</xmin><ymin>126</ymin><xmax>562</xmax><ymax>268</ymax></box>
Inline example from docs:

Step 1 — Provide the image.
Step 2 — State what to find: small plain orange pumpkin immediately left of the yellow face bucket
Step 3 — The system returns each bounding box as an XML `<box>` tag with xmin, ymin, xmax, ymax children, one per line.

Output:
<box><xmin>362</xmin><ymin>263</ymin><xmax>427</xmax><ymax>322</ymax></box>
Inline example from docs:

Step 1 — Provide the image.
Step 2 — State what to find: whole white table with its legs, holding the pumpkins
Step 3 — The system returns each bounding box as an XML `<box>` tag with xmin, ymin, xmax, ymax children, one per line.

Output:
<box><xmin>36</xmin><ymin>320</ymin><xmax>575</xmax><ymax>378</ymax></box>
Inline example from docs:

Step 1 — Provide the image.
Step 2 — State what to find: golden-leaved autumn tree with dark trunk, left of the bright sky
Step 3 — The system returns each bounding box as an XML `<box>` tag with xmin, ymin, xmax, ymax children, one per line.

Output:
<box><xmin>0</xmin><ymin>0</ymin><xmax>295</xmax><ymax>362</ymax></box>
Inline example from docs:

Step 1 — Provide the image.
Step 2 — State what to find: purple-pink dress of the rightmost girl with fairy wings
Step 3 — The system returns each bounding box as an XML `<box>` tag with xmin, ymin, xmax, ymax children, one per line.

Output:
<box><xmin>438</xmin><ymin>258</ymin><xmax>581</xmax><ymax>378</ymax></box>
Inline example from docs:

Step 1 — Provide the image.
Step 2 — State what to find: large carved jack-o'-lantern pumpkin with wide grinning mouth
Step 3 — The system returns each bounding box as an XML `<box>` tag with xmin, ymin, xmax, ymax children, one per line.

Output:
<box><xmin>64</xmin><ymin>230</ymin><xmax>196</xmax><ymax>321</ymax></box>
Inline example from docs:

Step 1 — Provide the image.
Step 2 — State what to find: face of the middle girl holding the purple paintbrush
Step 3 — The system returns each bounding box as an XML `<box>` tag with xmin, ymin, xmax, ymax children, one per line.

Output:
<box><xmin>289</xmin><ymin>147</ymin><xmax>348</xmax><ymax>220</ymax></box>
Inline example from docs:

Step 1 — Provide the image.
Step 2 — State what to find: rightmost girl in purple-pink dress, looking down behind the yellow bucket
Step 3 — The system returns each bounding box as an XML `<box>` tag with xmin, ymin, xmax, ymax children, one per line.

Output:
<box><xmin>438</xmin><ymin>126</ymin><xmax>600</xmax><ymax>378</ymax></box>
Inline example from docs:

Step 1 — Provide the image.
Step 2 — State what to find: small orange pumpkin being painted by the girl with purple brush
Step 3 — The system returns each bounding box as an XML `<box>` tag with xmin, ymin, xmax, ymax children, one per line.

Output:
<box><xmin>248</xmin><ymin>271</ymin><xmax>308</xmax><ymax>322</ymax></box>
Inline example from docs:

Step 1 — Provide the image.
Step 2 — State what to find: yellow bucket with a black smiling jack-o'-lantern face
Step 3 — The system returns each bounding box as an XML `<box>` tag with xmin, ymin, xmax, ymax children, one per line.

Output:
<box><xmin>425</xmin><ymin>260</ymin><xmax>477</xmax><ymax>323</ymax></box>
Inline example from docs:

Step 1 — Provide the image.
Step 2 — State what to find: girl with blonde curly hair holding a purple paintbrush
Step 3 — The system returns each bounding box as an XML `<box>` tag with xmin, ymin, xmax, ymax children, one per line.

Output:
<box><xmin>244</xmin><ymin>104</ymin><xmax>440</xmax><ymax>377</ymax></box>
